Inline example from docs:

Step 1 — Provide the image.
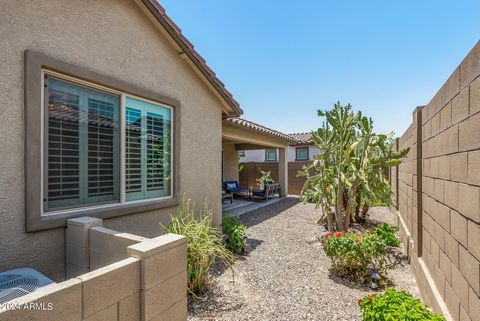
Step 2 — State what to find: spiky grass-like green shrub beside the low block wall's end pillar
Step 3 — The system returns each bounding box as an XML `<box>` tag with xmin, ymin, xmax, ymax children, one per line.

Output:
<box><xmin>162</xmin><ymin>199</ymin><xmax>235</xmax><ymax>294</ymax></box>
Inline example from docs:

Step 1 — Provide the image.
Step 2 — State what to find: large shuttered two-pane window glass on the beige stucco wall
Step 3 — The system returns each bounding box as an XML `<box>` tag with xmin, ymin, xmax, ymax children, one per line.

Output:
<box><xmin>44</xmin><ymin>75</ymin><xmax>172</xmax><ymax>212</ymax></box>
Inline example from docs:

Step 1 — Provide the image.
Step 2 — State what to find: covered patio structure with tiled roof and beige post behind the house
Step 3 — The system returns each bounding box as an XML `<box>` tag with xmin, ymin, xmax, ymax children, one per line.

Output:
<box><xmin>222</xmin><ymin>118</ymin><xmax>295</xmax><ymax>211</ymax></box>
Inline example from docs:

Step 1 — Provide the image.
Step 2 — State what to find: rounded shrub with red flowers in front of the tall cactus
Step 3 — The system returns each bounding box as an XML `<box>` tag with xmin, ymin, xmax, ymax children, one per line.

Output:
<box><xmin>322</xmin><ymin>232</ymin><xmax>387</xmax><ymax>280</ymax></box>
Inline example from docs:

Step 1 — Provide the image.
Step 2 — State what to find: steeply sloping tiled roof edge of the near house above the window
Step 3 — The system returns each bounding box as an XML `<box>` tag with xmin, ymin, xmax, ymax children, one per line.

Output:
<box><xmin>141</xmin><ymin>0</ymin><xmax>243</xmax><ymax>117</ymax></box>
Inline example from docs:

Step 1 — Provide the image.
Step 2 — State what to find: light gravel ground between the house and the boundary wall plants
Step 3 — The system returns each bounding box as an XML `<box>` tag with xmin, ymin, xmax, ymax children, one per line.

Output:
<box><xmin>188</xmin><ymin>197</ymin><xmax>418</xmax><ymax>321</ymax></box>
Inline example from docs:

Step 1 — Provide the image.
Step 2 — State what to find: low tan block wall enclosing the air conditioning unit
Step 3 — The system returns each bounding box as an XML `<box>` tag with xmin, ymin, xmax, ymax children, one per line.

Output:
<box><xmin>0</xmin><ymin>217</ymin><xmax>187</xmax><ymax>321</ymax></box>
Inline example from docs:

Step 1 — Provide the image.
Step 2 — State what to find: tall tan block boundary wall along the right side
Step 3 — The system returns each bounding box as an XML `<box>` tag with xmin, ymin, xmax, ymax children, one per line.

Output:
<box><xmin>390</xmin><ymin>42</ymin><xmax>480</xmax><ymax>321</ymax></box>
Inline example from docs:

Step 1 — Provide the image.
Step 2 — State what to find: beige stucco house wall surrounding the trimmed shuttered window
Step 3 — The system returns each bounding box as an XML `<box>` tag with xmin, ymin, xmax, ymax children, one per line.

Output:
<box><xmin>0</xmin><ymin>0</ymin><xmax>222</xmax><ymax>280</ymax></box>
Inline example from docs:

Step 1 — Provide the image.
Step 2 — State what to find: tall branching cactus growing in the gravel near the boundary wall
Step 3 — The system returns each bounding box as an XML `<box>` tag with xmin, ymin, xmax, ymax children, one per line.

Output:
<box><xmin>299</xmin><ymin>102</ymin><xmax>409</xmax><ymax>231</ymax></box>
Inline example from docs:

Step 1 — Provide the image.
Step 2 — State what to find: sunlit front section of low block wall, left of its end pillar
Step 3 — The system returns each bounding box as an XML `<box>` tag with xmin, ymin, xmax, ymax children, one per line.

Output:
<box><xmin>0</xmin><ymin>258</ymin><xmax>141</xmax><ymax>321</ymax></box>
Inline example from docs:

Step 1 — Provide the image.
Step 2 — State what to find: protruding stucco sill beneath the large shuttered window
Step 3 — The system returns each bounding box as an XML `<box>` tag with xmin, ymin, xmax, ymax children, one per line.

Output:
<box><xmin>26</xmin><ymin>198</ymin><xmax>178</xmax><ymax>232</ymax></box>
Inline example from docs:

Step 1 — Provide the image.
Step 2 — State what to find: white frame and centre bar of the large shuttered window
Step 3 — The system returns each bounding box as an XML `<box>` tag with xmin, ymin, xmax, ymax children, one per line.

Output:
<box><xmin>40</xmin><ymin>68</ymin><xmax>176</xmax><ymax>217</ymax></box>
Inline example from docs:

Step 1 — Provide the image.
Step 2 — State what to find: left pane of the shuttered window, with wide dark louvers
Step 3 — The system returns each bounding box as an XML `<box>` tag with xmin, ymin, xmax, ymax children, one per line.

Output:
<box><xmin>44</xmin><ymin>77</ymin><xmax>120</xmax><ymax>211</ymax></box>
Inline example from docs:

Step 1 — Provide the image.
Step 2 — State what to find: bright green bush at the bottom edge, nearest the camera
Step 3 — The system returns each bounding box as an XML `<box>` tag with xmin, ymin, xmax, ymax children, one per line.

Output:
<box><xmin>358</xmin><ymin>289</ymin><xmax>445</xmax><ymax>321</ymax></box>
